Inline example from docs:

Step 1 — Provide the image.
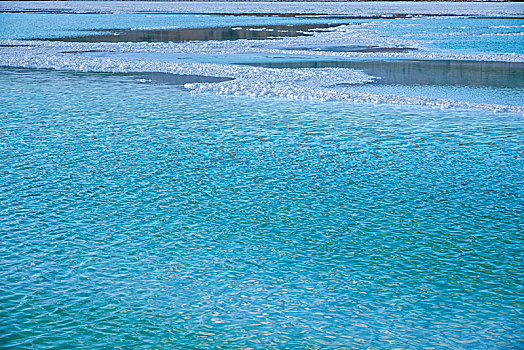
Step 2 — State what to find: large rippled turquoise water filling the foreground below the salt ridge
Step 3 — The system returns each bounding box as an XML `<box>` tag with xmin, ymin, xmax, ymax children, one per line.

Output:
<box><xmin>0</xmin><ymin>69</ymin><xmax>524</xmax><ymax>349</ymax></box>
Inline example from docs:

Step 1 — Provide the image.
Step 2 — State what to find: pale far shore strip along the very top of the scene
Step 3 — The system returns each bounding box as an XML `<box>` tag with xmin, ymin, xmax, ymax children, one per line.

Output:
<box><xmin>0</xmin><ymin>1</ymin><xmax>524</xmax><ymax>18</ymax></box>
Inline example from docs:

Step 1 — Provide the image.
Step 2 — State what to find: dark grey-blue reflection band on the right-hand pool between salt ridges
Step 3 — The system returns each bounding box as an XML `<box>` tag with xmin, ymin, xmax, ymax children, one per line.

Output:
<box><xmin>242</xmin><ymin>60</ymin><xmax>524</xmax><ymax>88</ymax></box>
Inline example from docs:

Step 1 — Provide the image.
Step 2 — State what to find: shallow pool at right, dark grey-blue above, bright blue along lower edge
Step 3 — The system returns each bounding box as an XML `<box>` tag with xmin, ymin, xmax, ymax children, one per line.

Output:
<box><xmin>243</xmin><ymin>58</ymin><xmax>524</xmax><ymax>106</ymax></box>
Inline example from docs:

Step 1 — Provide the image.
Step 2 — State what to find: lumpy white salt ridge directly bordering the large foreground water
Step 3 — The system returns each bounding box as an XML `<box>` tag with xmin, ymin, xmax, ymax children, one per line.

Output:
<box><xmin>0</xmin><ymin>40</ymin><xmax>524</xmax><ymax>114</ymax></box>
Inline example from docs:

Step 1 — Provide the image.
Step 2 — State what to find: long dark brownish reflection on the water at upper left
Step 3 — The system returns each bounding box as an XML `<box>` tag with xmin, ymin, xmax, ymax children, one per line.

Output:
<box><xmin>49</xmin><ymin>23</ymin><xmax>340</xmax><ymax>43</ymax></box>
